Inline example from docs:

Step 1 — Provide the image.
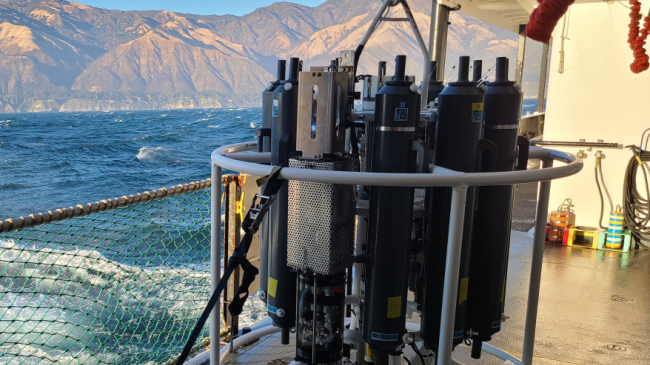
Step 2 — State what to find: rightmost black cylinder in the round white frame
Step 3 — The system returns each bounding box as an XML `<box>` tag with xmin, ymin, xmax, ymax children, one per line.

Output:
<box><xmin>467</xmin><ymin>57</ymin><xmax>522</xmax><ymax>354</ymax></box>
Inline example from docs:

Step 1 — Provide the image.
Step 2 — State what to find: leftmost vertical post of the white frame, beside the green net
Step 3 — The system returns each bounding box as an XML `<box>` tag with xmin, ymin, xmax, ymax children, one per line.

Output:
<box><xmin>210</xmin><ymin>164</ymin><xmax>221</xmax><ymax>365</ymax></box>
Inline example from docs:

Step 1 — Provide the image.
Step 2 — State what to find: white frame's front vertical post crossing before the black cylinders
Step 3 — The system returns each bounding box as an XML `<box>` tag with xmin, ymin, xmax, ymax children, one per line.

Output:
<box><xmin>437</xmin><ymin>186</ymin><xmax>467</xmax><ymax>365</ymax></box>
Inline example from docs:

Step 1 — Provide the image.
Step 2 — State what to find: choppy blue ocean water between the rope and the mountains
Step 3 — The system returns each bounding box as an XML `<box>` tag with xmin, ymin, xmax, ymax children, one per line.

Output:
<box><xmin>0</xmin><ymin>99</ymin><xmax>537</xmax><ymax>219</ymax></box>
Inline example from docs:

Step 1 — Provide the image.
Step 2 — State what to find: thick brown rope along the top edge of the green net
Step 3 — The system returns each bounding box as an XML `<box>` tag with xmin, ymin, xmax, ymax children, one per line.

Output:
<box><xmin>0</xmin><ymin>175</ymin><xmax>237</xmax><ymax>233</ymax></box>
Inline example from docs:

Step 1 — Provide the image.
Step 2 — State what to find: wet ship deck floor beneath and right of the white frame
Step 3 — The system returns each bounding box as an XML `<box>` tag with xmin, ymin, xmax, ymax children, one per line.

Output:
<box><xmin>225</xmin><ymin>183</ymin><xmax>650</xmax><ymax>365</ymax></box>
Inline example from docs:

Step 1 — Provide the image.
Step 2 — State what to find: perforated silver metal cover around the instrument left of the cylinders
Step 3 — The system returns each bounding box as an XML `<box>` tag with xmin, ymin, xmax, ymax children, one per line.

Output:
<box><xmin>287</xmin><ymin>158</ymin><xmax>359</xmax><ymax>275</ymax></box>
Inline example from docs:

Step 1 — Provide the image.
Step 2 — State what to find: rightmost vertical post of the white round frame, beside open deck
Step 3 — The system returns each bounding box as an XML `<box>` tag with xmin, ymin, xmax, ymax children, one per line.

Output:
<box><xmin>521</xmin><ymin>157</ymin><xmax>553</xmax><ymax>365</ymax></box>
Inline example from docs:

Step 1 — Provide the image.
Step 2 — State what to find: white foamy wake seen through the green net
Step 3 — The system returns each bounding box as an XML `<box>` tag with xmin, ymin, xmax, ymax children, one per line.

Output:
<box><xmin>0</xmin><ymin>239</ymin><xmax>210</xmax><ymax>364</ymax></box>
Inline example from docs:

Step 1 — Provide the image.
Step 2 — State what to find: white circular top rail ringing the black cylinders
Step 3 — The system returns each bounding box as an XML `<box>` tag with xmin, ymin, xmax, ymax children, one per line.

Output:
<box><xmin>212</xmin><ymin>143</ymin><xmax>583</xmax><ymax>187</ymax></box>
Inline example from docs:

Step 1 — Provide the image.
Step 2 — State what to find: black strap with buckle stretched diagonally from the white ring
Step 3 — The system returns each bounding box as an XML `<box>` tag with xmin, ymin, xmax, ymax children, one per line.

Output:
<box><xmin>176</xmin><ymin>167</ymin><xmax>285</xmax><ymax>365</ymax></box>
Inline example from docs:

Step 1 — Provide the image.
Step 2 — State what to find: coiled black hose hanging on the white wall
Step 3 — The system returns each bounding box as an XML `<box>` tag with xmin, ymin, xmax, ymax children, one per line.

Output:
<box><xmin>623</xmin><ymin>146</ymin><xmax>650</xmax><ymax>248</ymax></box>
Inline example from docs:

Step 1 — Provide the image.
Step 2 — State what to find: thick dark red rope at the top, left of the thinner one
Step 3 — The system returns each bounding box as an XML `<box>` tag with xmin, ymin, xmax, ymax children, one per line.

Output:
<box><xmin>526</xmin><ymin>0</ymin><xmax>576</xmax><ymax>42</ymax></box>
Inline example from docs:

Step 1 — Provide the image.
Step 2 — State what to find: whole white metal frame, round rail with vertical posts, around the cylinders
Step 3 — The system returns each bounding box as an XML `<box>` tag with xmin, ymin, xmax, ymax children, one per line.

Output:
<box><xmin>210</xmin><ymin>142</ymin><xmax>583</xmax><ymax>365</ymax></box>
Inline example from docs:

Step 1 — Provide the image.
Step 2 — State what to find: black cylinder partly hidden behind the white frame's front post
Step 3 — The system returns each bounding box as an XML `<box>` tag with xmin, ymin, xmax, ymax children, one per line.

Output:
<box><xmin>421</xmin><ymin>57</ymin><xmax>483</xmax><ymax>350</ymax></box>
